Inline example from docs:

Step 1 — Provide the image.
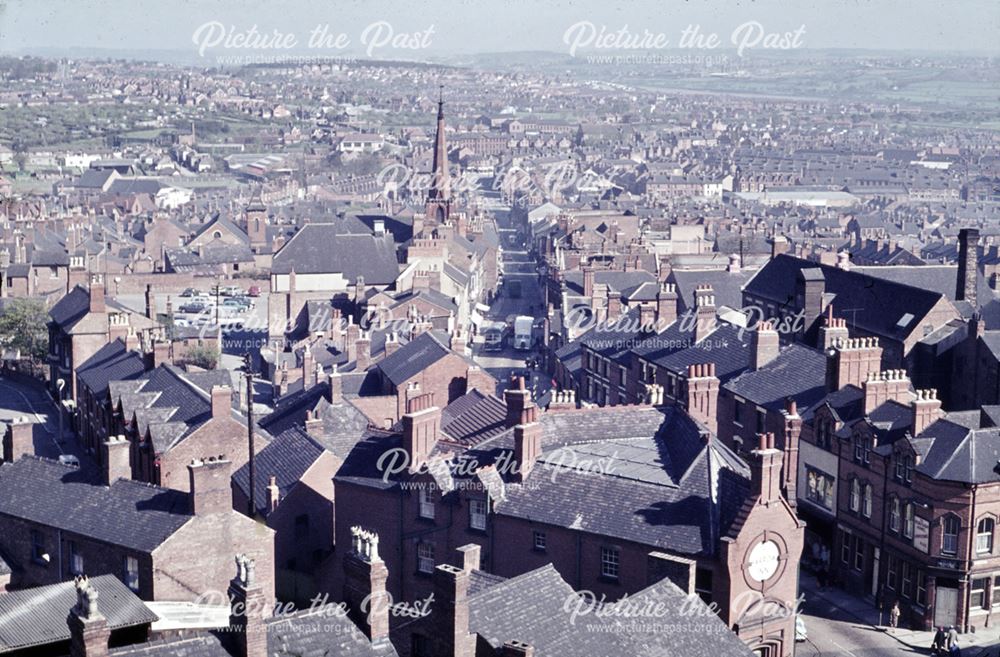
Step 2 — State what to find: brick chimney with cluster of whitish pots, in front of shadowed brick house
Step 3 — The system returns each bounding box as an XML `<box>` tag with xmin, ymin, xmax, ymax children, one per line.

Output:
<box><xmin>343</xmin><ymin>527</ymin><xmax>390</xmax><ymax>643</ymax></box>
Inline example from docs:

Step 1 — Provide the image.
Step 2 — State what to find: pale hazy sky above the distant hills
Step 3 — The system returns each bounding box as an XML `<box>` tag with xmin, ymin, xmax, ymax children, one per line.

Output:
<box><xmin>0</xmin><ymin>0</ymin><xmax>1000</xmax><ymax>59</ymax></box>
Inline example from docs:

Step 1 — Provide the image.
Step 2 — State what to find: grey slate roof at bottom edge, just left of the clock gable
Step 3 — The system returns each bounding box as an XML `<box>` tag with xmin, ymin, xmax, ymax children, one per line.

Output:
<box><xmin>469</xmin><ymin>564</ymin><xmax>752</xmax><ymax>657</ymax></box>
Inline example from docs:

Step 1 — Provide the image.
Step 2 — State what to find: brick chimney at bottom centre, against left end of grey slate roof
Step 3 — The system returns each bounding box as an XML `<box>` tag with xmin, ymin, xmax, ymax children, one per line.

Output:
<box><xmin>432</xmin><ymin>564</ymin><xmax>476</xmax><ymax>657</ymax></box>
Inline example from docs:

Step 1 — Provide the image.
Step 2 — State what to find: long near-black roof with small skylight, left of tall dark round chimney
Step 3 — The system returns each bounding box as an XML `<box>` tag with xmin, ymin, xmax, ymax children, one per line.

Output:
<box><xmin>744</xmin><ymin>254</ymin><xmax>945</xmax><ymax>340</ymax></box>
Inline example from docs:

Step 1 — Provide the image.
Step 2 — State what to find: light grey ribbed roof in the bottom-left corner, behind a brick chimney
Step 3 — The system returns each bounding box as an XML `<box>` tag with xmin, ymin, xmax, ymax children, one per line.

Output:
<box><xmin>0</xmin><ymin>575</ymin><xmax>157</xmax><ymax>654</ymax></box>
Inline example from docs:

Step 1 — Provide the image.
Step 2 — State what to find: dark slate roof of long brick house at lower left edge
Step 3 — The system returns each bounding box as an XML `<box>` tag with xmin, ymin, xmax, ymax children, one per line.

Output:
<box><xmin>0</xmin><ymin>456</ymin><xmax>193</xmax><ymax>552</ymax></box>
